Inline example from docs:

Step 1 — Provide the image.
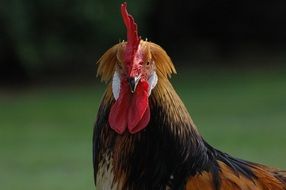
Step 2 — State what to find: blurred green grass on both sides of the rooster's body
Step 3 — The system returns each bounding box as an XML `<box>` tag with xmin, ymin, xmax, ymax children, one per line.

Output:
<box><xmin>0</xmin><ymin>71</ymin><xmax>286</xmax><ymax>190</ymax></box>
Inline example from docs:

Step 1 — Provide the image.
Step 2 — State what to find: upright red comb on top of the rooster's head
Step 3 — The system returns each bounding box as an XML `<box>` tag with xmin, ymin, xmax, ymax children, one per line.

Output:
<box><xmin>121</xmin><ymin>2</ymin><xmax>140</xmax><ymax>61</ymax></box>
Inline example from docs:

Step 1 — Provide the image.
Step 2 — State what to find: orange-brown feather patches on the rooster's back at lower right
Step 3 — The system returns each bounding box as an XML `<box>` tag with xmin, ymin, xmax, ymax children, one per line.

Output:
<box><xmin>186</xmin><ymin>161</ymin><xmax>286</xmax><ymax>190</ymax></box>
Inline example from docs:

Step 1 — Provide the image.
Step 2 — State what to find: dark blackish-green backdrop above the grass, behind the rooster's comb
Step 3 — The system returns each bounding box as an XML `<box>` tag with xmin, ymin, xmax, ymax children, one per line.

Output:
<box><xmin>0</xmin><ymin>0</ymin><xmax>286</xmax><ymax>85</ymax></box>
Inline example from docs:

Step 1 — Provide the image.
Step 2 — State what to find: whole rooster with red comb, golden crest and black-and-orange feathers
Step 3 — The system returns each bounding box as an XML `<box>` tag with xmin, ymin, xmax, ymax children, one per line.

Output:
<box><xmin>93</xmin><ymin>3</ymin><xmax>286</xmax><ymax>190</ymax></box>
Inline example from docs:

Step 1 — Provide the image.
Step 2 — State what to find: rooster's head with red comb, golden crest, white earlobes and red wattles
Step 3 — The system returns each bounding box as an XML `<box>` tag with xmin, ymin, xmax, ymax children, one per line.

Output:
<box><xmin>98</xmin><ymin>3</ymin><xmax>175</xmax><ymax>134</ymax></box>
